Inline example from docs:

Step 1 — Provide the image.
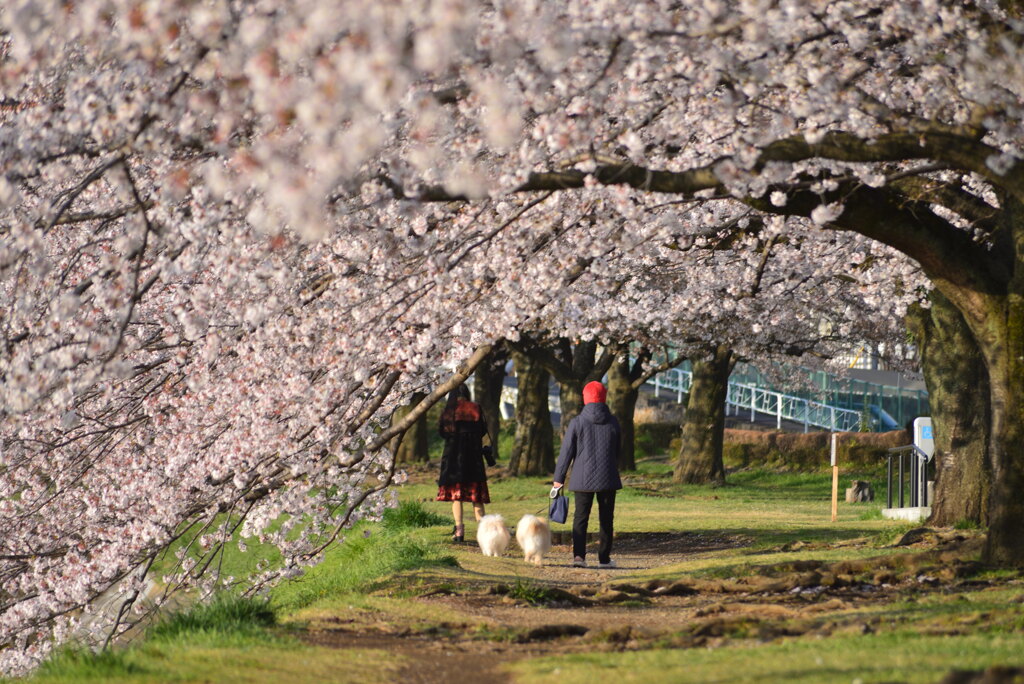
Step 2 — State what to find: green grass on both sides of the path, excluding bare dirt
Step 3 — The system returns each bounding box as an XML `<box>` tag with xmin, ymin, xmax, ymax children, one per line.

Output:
<box><xmin>22</xmin><ymin>453</ymin><xmax>1007</xmax><ymax>683</ymax></box>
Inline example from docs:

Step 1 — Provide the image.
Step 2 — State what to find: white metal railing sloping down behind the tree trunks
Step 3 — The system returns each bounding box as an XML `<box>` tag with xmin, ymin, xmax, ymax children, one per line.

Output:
<box><xmin>647</xmin><ymin>369</ymin><xmax>861</xmax><ymax>432</ymax></box>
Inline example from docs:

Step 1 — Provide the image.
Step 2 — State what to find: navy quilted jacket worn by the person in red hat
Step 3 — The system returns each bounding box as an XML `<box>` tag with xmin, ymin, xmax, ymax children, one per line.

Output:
<box><xmin>554</xmin><ymin>402</ymin><xmax>623</xmax><ymax>491</ymax></box>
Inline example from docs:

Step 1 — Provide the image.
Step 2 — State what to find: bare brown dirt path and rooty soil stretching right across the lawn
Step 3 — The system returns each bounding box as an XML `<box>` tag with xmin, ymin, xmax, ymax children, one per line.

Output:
<box><xmin>306</xmin><ymin>531</ymin><xmax>999</xmax><ymax>684</ymax></box>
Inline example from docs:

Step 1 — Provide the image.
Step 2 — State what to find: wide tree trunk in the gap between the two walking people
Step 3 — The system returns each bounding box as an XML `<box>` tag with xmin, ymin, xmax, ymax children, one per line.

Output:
<box><xmin>509</xmin><ymin>352</ymin><xmax>555</xmax><ymax>475</ymax></box>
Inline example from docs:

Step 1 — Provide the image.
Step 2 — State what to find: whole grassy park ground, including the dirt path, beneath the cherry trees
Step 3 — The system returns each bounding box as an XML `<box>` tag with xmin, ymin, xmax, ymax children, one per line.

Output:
<box><xmin>16</xmin><ymin>459</ymin><xmax>1024</xmax><ymax>684</ymax></box>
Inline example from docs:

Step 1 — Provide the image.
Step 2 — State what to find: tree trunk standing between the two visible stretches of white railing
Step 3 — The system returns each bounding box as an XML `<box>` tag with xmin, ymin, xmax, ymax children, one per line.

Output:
<box><xmin>674</xmin><ymin>345</ymin><xmax>732</xmax><ymax>484</ymax></box>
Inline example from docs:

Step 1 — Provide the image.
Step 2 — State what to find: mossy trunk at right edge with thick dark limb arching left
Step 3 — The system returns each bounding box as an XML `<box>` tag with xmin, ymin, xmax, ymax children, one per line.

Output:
<box><xmin>785</xmin><ymin>181</ymin><xmax>1024</xmax><ymax>567</ymax></box>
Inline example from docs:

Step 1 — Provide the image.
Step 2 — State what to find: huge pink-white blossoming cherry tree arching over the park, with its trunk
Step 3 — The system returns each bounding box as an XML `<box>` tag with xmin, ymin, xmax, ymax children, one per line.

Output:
<box><xmin>0</xmin><ymin>0</ymin><xmax>1024</xmax><ymax>672</ymax></box>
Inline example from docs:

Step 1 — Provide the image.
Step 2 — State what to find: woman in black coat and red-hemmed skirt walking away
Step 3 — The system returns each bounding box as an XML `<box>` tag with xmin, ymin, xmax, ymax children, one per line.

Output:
<box><xmin>437</xmin><ymin>385</ymin><xmax>494</xmax><ymax>542</ymax></box>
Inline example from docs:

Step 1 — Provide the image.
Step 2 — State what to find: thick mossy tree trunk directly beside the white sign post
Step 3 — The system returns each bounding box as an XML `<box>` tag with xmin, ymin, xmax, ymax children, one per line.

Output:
<box><xmin>907</xmin><ymin>291</ymin><xmax>991</xmax><ymax>525</ymax></box>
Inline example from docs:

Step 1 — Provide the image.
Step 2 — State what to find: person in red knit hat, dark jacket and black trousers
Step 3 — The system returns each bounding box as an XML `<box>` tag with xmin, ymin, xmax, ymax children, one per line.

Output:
<box><xmin>553</xmin><ymin>382</ymin><xmax>623</xmax><ymax>567</ymax></box>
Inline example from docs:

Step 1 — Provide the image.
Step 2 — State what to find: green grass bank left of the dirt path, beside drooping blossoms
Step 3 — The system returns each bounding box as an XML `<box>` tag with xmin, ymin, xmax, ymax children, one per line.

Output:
<box><xmin>22</xmin><ymin>502</ymin><xmax>453</xmax><ymax>683</ymax></box>
